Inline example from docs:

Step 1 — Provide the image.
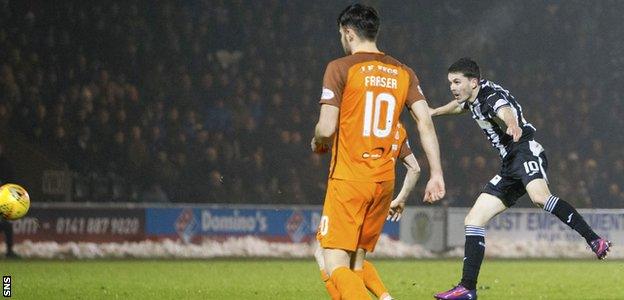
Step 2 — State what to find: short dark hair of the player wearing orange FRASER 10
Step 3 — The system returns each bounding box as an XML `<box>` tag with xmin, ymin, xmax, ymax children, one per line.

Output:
<box><xmin>337</xmin><ymin>4</ymin><xmax>379</xmax><ymax>41</ymax></box>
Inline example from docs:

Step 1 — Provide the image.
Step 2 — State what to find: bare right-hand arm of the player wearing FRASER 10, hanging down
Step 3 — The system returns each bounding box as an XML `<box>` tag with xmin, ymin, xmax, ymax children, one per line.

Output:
<box><xmin>410</xmin><ymin>100</ymin><xmax>446</xmax><ymax>203</ymax></box>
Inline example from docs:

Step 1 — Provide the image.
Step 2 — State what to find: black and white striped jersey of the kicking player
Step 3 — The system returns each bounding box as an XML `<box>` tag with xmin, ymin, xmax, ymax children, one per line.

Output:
<box><xmin>463</xmin><ymin>79</ymin><xmax>536</xmax><ymax>158</ymax></box>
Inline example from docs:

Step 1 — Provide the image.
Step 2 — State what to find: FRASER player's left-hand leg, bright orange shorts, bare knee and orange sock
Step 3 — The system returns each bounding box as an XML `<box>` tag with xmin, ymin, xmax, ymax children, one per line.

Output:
<box><xmin>317</xmin><ymin>179</ymin><xmax>374</xmax><ymax>299</ymax></box>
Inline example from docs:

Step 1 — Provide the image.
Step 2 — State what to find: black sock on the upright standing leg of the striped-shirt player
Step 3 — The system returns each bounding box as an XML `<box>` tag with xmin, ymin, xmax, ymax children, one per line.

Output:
<box><xmin>460</xmin><ymin>225</ymin><xmax>485</xmax><ymax>290</ymax></box>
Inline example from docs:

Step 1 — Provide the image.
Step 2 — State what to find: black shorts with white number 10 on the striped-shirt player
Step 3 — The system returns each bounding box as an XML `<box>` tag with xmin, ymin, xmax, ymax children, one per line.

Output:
<box><xmin>483</xmin><ymin>140</ymin><xmax>548</xmax><ymax>207</ymax></box>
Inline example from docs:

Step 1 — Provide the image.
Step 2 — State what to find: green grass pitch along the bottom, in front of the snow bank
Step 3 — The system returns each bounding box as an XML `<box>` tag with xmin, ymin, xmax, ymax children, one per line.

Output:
<box><xmin>0</xmin><ymin>259</ymin><xmax>624</xmax><ymax>300</ymax></box>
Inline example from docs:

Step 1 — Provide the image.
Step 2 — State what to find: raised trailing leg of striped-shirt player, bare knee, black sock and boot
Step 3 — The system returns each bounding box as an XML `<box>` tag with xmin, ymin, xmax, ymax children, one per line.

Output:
<box><xmin>526</xmin><ymin>179</ymin><xmax>611</xmax><ymax>259</ymax></box>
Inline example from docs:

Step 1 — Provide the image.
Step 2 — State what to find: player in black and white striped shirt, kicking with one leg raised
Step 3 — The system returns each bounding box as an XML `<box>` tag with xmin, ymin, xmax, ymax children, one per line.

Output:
<box><xmin>430</xmin><ymin>58</ymin><xmax>611</xmax><ymax>299</ymax></box>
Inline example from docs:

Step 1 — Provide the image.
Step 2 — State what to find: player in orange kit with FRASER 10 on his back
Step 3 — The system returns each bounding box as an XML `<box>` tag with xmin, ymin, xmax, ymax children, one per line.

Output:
<box><xmin>311</xmin><ymin>4</ymin><xmax>445</xmax><ymax>299</ymax></box>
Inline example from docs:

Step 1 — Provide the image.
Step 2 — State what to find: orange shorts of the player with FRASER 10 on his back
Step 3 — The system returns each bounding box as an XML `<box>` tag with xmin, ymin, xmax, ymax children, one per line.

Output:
<box><xmin>316</xmin><ymin>179</ymin><xmax>394</xmax><ymax>252</ymax></box>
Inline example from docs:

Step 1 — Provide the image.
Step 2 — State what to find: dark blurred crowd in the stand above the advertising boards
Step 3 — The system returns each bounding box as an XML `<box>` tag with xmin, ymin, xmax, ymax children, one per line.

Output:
<box><xmin>0</xmin><ymin>0</ymin><xmax>624</xmax><ymax>207</ymax></box>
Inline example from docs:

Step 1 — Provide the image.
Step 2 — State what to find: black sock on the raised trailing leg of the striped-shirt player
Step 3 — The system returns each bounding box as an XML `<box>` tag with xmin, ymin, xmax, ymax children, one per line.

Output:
<box><xmin>544</xmin><ymin>195</ymin><xmax>599</xmax><ymax>244</ymax></box>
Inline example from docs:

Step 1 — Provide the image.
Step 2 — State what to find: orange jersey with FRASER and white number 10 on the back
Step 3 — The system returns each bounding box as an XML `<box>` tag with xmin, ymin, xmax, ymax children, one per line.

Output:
<box><xmin>320</xmin><ymin>53</ymin><xmax>425</xmax><ymax>182</ymax></box>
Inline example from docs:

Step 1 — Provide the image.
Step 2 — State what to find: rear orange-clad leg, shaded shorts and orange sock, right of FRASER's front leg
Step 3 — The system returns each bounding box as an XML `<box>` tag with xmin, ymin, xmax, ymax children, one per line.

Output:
<box><xmin>353</xmin><ymin>181</ymin><xmax>394</xmax><ymax>300</ymax></box>
